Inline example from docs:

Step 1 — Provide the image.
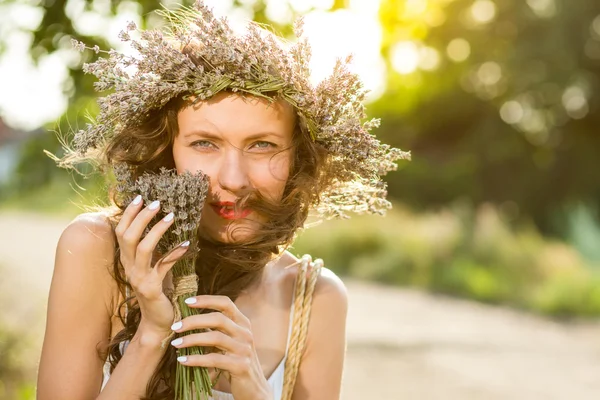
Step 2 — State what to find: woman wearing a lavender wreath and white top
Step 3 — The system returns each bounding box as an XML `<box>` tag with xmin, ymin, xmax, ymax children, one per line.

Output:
<box><xmin>38</xmin><ymin>3</ymin><xmax>408</xmax><ymax>400</ymax></box>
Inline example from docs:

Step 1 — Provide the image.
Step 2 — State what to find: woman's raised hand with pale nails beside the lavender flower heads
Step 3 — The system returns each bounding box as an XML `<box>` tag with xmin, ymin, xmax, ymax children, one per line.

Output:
<box><xmin>115</xmin><ymin>196</ymin><xmax>189</xmax><ymax>338</ymax></box>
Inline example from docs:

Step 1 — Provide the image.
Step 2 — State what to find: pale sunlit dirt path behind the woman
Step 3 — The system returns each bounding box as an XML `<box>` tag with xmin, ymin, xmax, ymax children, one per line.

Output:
<box><xmin>0</xmin><ymin>212</ymin><xmax>600</xmax><ymax>400</ymax></box>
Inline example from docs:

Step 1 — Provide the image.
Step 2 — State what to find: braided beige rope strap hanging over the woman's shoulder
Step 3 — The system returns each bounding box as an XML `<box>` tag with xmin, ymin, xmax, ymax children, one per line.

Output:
<box><xmin>281</xmin><ymin>255</ymin><xmax>323</xmax><ymax>400</ymax></box>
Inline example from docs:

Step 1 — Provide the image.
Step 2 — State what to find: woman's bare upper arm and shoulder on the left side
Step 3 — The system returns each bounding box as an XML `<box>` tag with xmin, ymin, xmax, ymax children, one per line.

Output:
<box><xmin>37</xmin><ymin>213</ymin><xmax>115</xmax><ymax>400</ymax></box>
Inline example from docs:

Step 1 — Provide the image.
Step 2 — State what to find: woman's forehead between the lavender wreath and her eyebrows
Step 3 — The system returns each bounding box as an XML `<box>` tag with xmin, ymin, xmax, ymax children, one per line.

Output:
<box><xmin>177</xmin><ymin>92</ymin><xmax>296</xmax><ymax>136</ymax></box>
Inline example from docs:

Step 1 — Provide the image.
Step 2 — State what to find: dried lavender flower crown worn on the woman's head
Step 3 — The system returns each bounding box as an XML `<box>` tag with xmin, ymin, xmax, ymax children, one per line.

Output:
<box><xmin>73</xmin><ymin>1</ymin><xmax>410</xmax><ymax>218</ymax></box>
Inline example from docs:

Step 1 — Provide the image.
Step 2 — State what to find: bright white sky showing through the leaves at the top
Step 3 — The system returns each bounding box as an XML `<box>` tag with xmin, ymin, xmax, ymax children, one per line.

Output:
<box><xmin>0</xmin><ymin>0</ymin><xmax>385</xmax><ymax>130</ymax></box>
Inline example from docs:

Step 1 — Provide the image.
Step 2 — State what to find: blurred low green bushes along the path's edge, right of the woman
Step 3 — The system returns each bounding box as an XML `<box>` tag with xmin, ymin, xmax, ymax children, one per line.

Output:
<box><xmin>291</xmin><ymin>202</ymin><xmax>600</xmax><ymax>317</ymax></box>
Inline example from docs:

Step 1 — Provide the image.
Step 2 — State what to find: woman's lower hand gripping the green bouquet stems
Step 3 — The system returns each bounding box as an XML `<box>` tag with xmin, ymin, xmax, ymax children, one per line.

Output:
<box><xmin>171</xmin><ymin>295</ymin><xmax>273</xmax><ymax>400</ymax></box>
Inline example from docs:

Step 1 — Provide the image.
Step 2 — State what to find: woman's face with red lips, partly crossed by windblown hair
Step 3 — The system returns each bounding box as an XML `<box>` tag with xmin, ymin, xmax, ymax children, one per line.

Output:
<box><xmin>173</xmin><ymin>92</ymin><xmax>295</xmax><ymax>242</ymax></box>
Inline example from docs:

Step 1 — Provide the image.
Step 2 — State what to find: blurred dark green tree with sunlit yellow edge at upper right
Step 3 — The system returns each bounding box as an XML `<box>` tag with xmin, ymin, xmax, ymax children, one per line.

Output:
<box><xmin>372</xmin><ymin>0</ymin><xmax>600</xmax><ymax>233</ymax></box>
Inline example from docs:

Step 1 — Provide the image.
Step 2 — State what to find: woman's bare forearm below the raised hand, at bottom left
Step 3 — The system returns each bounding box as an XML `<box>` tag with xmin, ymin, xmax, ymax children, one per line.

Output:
<box><xmin>97</xmin><ymin>329</ymin><xmax>166</xmax><ymax>400</ymax></box>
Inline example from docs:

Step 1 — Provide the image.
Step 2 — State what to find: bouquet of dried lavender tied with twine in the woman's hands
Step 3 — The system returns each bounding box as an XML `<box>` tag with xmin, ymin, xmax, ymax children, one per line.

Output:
<box><xmin>114</xmin><ymin>164</ymin><xmax>218</xmax><ymax>400</ymax></box>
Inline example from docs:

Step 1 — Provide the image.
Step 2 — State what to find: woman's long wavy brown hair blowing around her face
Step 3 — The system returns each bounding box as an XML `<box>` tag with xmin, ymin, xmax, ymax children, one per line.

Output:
<box><xmin>104</xmin><ymin>90</ymin><xmax>327</xmax><ymax>400</ymax></box>
